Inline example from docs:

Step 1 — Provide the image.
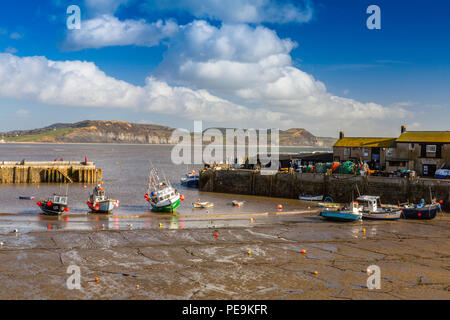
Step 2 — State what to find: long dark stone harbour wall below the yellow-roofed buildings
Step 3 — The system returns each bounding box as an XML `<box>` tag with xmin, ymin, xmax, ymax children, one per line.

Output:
<box><xmin>199</xmin><ymin>169</ymin><xmax>450</xmax><ymax>210</ymax></box>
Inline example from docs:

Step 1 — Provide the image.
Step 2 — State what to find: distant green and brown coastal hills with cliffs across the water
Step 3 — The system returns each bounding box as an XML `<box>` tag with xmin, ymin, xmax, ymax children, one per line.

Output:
<box><xmin>0</xmin><ymin>120</ymin><xmax>336</xmax><ymax>147</ymax></box>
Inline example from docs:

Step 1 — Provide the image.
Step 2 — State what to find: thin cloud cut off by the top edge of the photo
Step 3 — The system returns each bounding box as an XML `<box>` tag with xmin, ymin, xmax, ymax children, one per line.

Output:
<box><xmin>144</xmin><ymin>0</ymin><xmax>313</xmax><ymax>23</ymax></box>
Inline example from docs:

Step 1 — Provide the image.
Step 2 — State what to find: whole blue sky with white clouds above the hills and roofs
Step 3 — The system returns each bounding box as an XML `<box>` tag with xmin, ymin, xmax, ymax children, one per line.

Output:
<box><xmin>0</xmin><ymin>0</ymin><xmax>450</xmax><ymax>137</ymax></box>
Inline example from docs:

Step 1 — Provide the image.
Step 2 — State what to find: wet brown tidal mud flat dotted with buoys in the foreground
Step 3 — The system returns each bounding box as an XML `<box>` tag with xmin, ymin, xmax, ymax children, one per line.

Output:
<box><xmin>0</xmin><ymin>214</ymin><xmax>450</xmax><ymax>299</ymax></box>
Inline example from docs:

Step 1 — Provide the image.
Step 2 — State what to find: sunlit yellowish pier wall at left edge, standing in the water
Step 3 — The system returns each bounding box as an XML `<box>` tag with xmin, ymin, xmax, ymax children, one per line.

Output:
<box><xmin>0</xmin><ymin>161</ymin><xmax>102</xmax><ymax>184</ymax></box>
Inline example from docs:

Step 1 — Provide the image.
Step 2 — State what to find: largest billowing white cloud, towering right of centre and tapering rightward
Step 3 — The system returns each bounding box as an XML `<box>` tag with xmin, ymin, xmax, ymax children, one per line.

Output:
<box><xmin>152</xmin><ymin>21</ymin><xmax>405</xmax><ymax>134</ymax></box>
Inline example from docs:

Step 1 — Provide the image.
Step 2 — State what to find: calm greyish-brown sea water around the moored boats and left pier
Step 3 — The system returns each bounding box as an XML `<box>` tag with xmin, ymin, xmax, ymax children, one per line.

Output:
<box><xmin>0</xmin><ymin>144</ymin><xmax>326</xmax><ymax>233</ymax></box>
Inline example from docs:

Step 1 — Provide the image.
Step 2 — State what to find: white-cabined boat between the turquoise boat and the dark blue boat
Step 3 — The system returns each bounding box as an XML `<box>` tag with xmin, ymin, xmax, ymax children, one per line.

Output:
<box><xmin>356</xmin><ymin>195</ymin><xmax>402</xmax><ymax>220</ymax></box>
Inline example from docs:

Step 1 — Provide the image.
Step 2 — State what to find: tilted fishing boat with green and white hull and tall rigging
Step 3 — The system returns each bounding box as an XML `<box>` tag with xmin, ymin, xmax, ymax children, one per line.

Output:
<box><xmin>145</xmin><ymin>168</ymin><xmax>180</xmax><ymax>213</ymax></box>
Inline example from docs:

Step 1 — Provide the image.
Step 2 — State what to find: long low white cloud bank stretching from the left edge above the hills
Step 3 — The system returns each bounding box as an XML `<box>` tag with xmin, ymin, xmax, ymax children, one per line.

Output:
<box><xmin>0</xmin><ymin>54</ymin><xmax>280</xmax><ymax>123</ymax></box>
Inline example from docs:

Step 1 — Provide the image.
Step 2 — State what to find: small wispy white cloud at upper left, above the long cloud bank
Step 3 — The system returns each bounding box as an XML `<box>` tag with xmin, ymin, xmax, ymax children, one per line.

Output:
<box><xmin>65</xmin><ymin>14</ymin><xmax>178</xmax><ymax>50</ymax></box>
